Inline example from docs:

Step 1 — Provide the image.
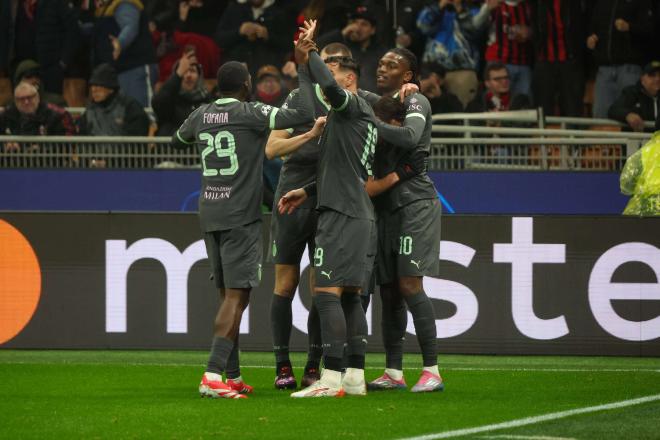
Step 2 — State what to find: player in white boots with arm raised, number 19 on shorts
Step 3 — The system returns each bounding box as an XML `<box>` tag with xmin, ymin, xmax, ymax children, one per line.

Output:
<box><xmin>278</xmin><ymin>24</ymin><xmax>377</xmax><ymax>398</ymax></box>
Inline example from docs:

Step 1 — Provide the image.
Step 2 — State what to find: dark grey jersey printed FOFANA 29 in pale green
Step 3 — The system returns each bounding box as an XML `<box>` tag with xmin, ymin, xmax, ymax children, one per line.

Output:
<box><xmin>175</xmin><ymin>75</ymin><xmax>313</xmax><ymax>232</ymax></box>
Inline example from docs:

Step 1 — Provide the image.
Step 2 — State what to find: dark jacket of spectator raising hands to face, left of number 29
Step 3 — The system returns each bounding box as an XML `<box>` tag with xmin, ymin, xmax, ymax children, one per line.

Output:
<box><xmin>151</xmin><ymin>61</ymin><xmax>211</xmax><ymax>136</ymax></box>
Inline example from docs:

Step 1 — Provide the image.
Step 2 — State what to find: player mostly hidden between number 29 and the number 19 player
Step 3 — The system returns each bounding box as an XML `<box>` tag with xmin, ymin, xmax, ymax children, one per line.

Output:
<box><xmin>266</xmin><ymin>43</ymin><xmax>379</xmax><ymax>389</ymax></box>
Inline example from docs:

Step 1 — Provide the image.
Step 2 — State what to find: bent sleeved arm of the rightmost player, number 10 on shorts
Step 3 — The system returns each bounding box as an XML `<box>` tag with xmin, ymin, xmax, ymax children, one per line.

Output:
<box><xmin>376</xmin><ymin>93</ymin><xmax>431</xmax><ymax>149</ymax></box>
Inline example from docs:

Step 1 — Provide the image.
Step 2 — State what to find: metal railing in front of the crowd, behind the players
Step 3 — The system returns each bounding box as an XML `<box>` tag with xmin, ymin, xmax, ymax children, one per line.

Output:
<box><xmin>0</xmin><ymin>110</ymin><xmax>651</xmax><ymax>170</ymax></box>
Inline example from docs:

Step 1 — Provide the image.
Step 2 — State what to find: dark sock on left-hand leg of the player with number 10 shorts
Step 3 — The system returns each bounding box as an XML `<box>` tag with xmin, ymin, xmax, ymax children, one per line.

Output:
<box><xmin>380</xmin><ymin>286</ymin><xmax>408</xmax><ymax>370</ymax></box>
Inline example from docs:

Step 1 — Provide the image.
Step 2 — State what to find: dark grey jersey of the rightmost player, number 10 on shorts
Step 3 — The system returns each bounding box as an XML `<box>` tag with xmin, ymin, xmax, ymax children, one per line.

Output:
<box><xmin>377</xmin><ymin>93</ymin><xmax>437</xmax><ymax>210</ymax></box>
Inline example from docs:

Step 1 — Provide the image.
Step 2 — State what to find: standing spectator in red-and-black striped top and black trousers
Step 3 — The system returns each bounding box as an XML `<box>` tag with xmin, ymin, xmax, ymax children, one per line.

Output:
<box><xmin>531</xmin><ymin>0</ymin><xmax>585</xmax><ymax>117</ymax></box>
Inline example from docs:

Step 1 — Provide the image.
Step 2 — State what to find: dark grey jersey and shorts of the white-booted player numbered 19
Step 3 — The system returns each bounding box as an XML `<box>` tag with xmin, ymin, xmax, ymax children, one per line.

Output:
<box><xmin>310</xmin><ymin>54</ymin><xmax>378</xmax><ymax>287</ymax></box>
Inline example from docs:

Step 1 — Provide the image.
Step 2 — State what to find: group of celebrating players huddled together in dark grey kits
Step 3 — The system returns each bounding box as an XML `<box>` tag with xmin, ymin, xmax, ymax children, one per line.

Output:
<box><xmin>172</xmin><ymin>21</ymin><xmax>444</xmax><ymax>399</ymax></box>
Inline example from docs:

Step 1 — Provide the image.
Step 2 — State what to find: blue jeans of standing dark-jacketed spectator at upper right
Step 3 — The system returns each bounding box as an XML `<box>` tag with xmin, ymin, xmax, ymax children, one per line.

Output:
<box><xmin>593</xmin><ymin>64</ymin><xmax>642</xmax><ymax>118</ymax></box>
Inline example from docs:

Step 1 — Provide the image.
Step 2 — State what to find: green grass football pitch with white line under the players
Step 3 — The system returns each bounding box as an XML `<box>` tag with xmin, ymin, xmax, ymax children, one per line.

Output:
<box><xmin>0</xmin><ymin>350</ymin><xmax>660</xmax><ymax>440</ymax></box>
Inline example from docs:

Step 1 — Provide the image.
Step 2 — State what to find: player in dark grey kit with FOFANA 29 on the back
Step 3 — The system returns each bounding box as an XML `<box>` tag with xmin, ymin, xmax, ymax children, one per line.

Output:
<box><xmin>172</xmin><ymin>40</ymin><xmax>314</xmax><ymax>399</ymax></box>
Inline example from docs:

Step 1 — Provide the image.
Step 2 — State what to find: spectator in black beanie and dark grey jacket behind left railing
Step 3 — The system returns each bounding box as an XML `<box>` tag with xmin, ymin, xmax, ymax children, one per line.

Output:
<box><xmin>79</xmin><ymin>64</ymin><xmax>149</xmax><ymax>136</ymax></box>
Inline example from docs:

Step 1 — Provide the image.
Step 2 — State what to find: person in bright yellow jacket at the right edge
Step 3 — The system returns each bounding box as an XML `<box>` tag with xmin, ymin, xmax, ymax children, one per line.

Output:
<box><xmin>619</xmin><ymin>119</ymin><xmax>660</xmax><ymax>216</ymax></box>
